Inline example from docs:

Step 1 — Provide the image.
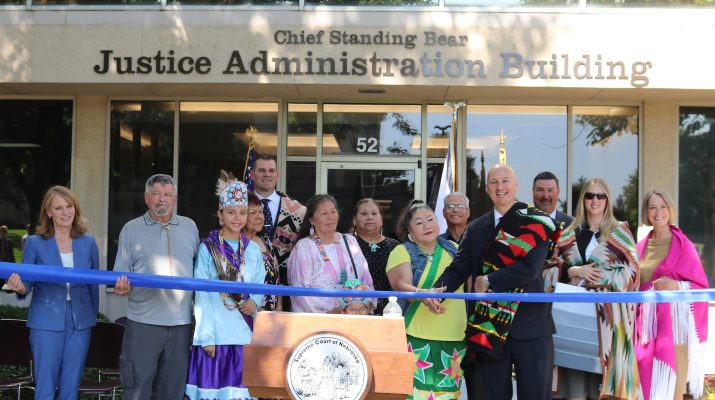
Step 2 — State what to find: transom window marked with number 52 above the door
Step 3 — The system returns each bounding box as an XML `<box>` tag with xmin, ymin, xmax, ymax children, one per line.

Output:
<box><xmin>323</xmin><ymin>104</ymin><xmax>421</xmax><ymax>156</ymax></box>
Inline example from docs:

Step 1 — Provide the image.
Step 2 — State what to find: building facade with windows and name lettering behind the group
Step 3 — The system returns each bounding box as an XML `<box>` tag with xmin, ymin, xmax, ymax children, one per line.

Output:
<box><xmin>0</xmin><ymin>0</ymin><xmax>715</xmax><ymax>316</ymax></box>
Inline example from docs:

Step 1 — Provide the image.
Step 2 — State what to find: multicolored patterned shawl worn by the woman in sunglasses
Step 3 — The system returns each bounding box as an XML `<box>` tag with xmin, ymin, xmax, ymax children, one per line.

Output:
<box><xmin>559</xmin><ymin>222</ymin><xmax>643</xmax><ymax>399</ymax></box>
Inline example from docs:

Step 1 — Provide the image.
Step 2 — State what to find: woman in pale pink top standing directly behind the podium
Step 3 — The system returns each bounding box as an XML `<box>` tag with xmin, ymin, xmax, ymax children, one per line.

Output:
<box><xmin>288</xmin><ymin>194</ymin><xmax>376</xmax><ymax>314</ymax></box>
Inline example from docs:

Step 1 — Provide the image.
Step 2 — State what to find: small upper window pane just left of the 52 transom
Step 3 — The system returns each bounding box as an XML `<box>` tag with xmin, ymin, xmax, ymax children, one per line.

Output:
<box><xmin>286</xmin><ymin>103</ymin><xmax>318</xmax><ymax>156</ymax></box>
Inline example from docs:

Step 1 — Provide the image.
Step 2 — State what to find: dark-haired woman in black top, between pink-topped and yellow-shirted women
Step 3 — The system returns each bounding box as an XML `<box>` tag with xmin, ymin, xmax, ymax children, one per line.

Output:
<box><xmin>353</xmin><ymin>197</ymin><xmax>400</xmax><ymax>315</ymax></box>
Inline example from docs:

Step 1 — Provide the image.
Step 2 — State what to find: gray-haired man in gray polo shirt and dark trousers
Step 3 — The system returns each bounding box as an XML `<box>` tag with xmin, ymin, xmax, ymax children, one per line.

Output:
<box><xmin>114</xmin><ymin>174</ymin><xmax>199</xmax><ymax>400</ymax></box>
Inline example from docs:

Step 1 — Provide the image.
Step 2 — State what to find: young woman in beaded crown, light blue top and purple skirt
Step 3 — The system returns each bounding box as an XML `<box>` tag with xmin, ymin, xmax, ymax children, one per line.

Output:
<box><xmin>186</xmin><ymin>171</ymin><xmax>266</xmax><ymax>400</ymax></box>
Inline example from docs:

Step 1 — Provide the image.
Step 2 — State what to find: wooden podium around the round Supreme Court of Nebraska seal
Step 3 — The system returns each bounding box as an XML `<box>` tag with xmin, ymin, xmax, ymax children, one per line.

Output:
<box><xmin>243</xmin><ymin>311</ymin><xmax>414</xmax><ymax>399</ymax></box>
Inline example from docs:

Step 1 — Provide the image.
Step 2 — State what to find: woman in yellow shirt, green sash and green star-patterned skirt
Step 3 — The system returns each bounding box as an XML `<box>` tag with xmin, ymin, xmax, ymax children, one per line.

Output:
<box><xmin>387</xmin><ymin>200</ymin><xmax>467</xmax><ymax>399</ymax></box>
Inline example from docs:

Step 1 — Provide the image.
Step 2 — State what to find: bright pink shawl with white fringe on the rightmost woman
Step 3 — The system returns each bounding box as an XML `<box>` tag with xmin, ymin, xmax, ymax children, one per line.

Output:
<box><xmin>635</xmin><ymin>225</ymin><xmax>708</xmax><ymax>400</ymax></box>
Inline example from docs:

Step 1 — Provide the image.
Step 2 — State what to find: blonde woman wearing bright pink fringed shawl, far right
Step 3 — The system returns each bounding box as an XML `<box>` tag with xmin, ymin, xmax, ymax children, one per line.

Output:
<box><xmin>635</xmin><ymin>189</ymin><xmax>708</xmax><ymax>400</ymax></box>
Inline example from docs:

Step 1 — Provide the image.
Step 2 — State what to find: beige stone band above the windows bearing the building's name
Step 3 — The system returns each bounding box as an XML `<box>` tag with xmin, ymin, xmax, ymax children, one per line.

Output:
<box><xmin>0</xmin><ymin>9</ymin><xmax>715</xmax><ymax>89</ymax></box>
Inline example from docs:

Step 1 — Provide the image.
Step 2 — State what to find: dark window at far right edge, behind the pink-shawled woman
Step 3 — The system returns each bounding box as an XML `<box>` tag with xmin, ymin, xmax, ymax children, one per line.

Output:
<box><xmin>678</xmin><ymin>107</ymin><xmax>715</xmax><ymax>287</ymax></box>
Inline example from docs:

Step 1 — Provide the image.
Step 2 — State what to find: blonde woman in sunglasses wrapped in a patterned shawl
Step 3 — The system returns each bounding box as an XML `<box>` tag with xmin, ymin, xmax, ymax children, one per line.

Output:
<box><xmin>558</xmin><ymin>178</ymin><xmax>643</xmax><ymax>399</ymax></box>
